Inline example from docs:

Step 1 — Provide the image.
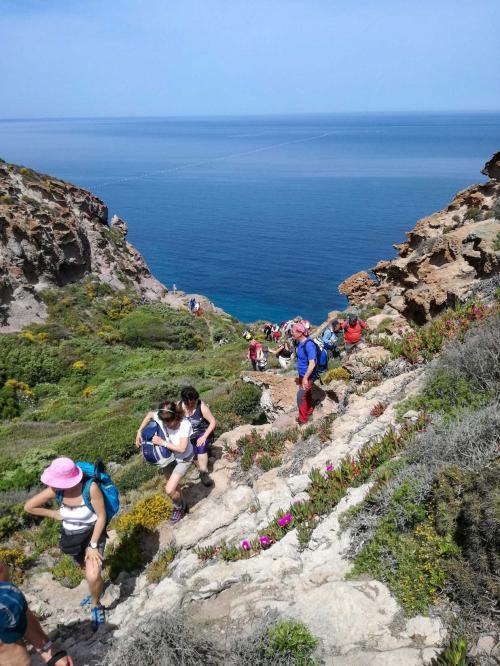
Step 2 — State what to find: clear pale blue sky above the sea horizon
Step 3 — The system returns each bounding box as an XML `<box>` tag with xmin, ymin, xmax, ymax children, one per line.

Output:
<box><xmin>0</xmin><ymin>0</ymin><xmax>500</xmax><ymax>118</ymax></box>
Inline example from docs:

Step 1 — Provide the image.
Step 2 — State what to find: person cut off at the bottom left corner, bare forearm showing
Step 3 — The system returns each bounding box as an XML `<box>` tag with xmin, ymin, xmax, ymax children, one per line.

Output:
<box><xmin>0</xmin><ymin>562</ymin><xmax>73</xmax><ymax>666</ymax></box>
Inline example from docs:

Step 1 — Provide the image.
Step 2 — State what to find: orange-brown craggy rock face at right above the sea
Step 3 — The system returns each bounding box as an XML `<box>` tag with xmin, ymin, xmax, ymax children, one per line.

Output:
<box><xmin>339</xmin><ymin>153</ymin><xmax>500</xmax><ymax>324</ymax></box>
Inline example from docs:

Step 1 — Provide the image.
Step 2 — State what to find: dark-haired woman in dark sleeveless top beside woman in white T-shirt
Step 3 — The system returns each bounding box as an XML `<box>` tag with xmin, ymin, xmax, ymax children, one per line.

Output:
<box><xmin>181</xmin><ymin>386</ymin><xmax>217</xmax><ymax>487</ymax></box>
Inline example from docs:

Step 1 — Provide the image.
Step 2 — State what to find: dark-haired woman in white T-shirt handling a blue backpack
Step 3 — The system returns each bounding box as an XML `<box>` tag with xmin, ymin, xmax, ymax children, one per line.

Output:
<box><xmin>135</xmin><ymin>401</ymin><xmax>194</xmax><ymax>525</ymax></box>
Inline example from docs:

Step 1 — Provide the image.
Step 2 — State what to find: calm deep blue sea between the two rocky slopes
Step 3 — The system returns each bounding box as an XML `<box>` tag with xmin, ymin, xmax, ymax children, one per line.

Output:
<box><xmin>0</xmin><ymin>113</ymin><xmax>500</xmax><ymax>322</ymax></box>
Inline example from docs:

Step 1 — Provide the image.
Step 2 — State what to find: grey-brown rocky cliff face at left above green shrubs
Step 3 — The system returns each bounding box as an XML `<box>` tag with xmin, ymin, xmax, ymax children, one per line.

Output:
<box><xmin>0</xmin><ymin>162</ymin><xmax>167</xmax><ymax>332</ymax></box>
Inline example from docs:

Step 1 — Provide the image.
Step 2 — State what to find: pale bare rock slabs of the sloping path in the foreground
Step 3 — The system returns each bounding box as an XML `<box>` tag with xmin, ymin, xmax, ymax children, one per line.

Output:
<box><xmin>25</xmin><ymin>364</ymin><xmax>444</xmax><ymax>666</ymax></box>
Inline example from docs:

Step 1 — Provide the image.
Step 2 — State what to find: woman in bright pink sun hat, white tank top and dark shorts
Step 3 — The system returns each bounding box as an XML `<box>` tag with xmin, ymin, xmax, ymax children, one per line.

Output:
<box><xmin>24</xmin><ymin>458</ymin><xmax>107</xmax><ymax>631</ymax></box>
